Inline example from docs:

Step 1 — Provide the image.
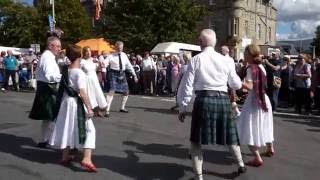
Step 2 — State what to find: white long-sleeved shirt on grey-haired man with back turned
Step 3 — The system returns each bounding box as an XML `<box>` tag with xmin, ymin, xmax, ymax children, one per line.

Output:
<box><xmin>177</xmin><ymin>47</ymin><xmax>242</xmax><ymax>107</ymax></box>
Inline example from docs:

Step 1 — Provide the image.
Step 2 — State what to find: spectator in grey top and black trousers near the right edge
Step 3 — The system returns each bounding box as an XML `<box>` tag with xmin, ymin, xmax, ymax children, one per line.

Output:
<box><xmin>293</xmin><ymin>54</ymin><xmax>312</xmax><ymax>114</ymax></box>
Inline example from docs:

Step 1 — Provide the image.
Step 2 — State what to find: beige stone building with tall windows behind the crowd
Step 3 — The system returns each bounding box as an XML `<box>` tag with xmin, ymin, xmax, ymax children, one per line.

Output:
<box><xmin>199</xmin><ymin>0</ymin><xmax>277</xmax><ymax>59</ymax></box>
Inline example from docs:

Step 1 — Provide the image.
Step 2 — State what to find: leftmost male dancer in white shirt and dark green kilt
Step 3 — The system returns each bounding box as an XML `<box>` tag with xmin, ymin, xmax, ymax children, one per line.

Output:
<box><xmin>29</xmin><ymin>36</ymin><xmax>61</xmax><ymax>148</ymax></box>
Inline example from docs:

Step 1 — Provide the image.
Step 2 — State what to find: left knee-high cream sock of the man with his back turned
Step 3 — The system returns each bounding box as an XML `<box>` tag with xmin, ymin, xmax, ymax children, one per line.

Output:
<box><xmin>190</xmin><ymin>143</ymin><xmax>203</xmax><ymax>179</ymax></box>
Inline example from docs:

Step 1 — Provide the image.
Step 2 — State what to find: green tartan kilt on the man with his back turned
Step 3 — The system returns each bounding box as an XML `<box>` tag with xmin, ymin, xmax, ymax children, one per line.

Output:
<box><xmin>190</xmin><ymin>96</ymin><xmax>239</xmax><ymax>145</ymax></box>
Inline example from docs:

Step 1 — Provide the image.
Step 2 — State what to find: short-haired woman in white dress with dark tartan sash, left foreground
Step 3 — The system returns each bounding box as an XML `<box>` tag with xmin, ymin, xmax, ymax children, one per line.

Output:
<box><xmin>50</xmin><ymin>45</ymin><xmax>97</xmax><ymax>172</ymax></box>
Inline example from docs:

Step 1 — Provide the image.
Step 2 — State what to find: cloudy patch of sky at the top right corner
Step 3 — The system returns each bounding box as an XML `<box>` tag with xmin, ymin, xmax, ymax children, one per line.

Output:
<box><xmin>274</xmin><ymin>0</ymin><xmax>320</xmax><ymax>39</ymax></box>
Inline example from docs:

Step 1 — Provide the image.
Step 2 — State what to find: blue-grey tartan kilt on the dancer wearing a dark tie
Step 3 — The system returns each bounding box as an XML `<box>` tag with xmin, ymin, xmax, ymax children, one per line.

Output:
<box><xmin>106</xmin><ymin>69</ymin><xmax>129</xmax><ymax>93</ymax></box>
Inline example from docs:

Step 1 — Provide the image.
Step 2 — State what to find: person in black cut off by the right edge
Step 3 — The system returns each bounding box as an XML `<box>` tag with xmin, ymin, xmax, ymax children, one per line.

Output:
<box><xmin>311</xmin><ymin>58</ymin><xmax>320</xmax><ymax>115</ymax></box>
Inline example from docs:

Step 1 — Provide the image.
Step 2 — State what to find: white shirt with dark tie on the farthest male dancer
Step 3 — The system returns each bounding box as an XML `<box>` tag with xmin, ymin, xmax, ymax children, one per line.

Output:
<box><xmin>105</xmin><ymin>52</ymin><xmax>136</xmax><ymax>76</ymax></box>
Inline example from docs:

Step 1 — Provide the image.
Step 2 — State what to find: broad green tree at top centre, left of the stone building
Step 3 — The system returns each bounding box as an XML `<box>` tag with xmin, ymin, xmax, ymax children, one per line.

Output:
<box><xmin>96</xmin><ymin>0</ymin><xmax>205</xmax><ymax>52</ymax></box>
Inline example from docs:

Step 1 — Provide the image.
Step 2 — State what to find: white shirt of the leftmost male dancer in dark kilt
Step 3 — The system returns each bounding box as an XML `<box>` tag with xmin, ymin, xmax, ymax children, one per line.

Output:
<box><xmin>36</xmin><ymin>50</ymin><xmax>61</xmax><ymax>83</ymax></box>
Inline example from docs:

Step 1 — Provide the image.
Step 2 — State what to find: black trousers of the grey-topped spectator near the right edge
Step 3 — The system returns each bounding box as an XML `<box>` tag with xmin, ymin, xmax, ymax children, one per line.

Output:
<box><xmin>294</xmin><ymin>88</ymin><xmax>311</xmax><ymax>113</ymax></box>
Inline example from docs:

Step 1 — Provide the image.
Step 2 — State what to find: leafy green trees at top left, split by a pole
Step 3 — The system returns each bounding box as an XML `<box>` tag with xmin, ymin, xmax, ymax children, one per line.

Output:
<box><xmin>0</xmin><ymin>0</ymin><xmax>91</xmax><ymax>49</ymax></box>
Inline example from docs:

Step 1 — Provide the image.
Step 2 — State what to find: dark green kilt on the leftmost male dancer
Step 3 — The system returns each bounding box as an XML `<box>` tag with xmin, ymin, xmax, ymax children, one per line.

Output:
<box><xmin>29</xmin><ymin>81</ymin><xmax>57</xmax><ymax>121</ymax></box>
